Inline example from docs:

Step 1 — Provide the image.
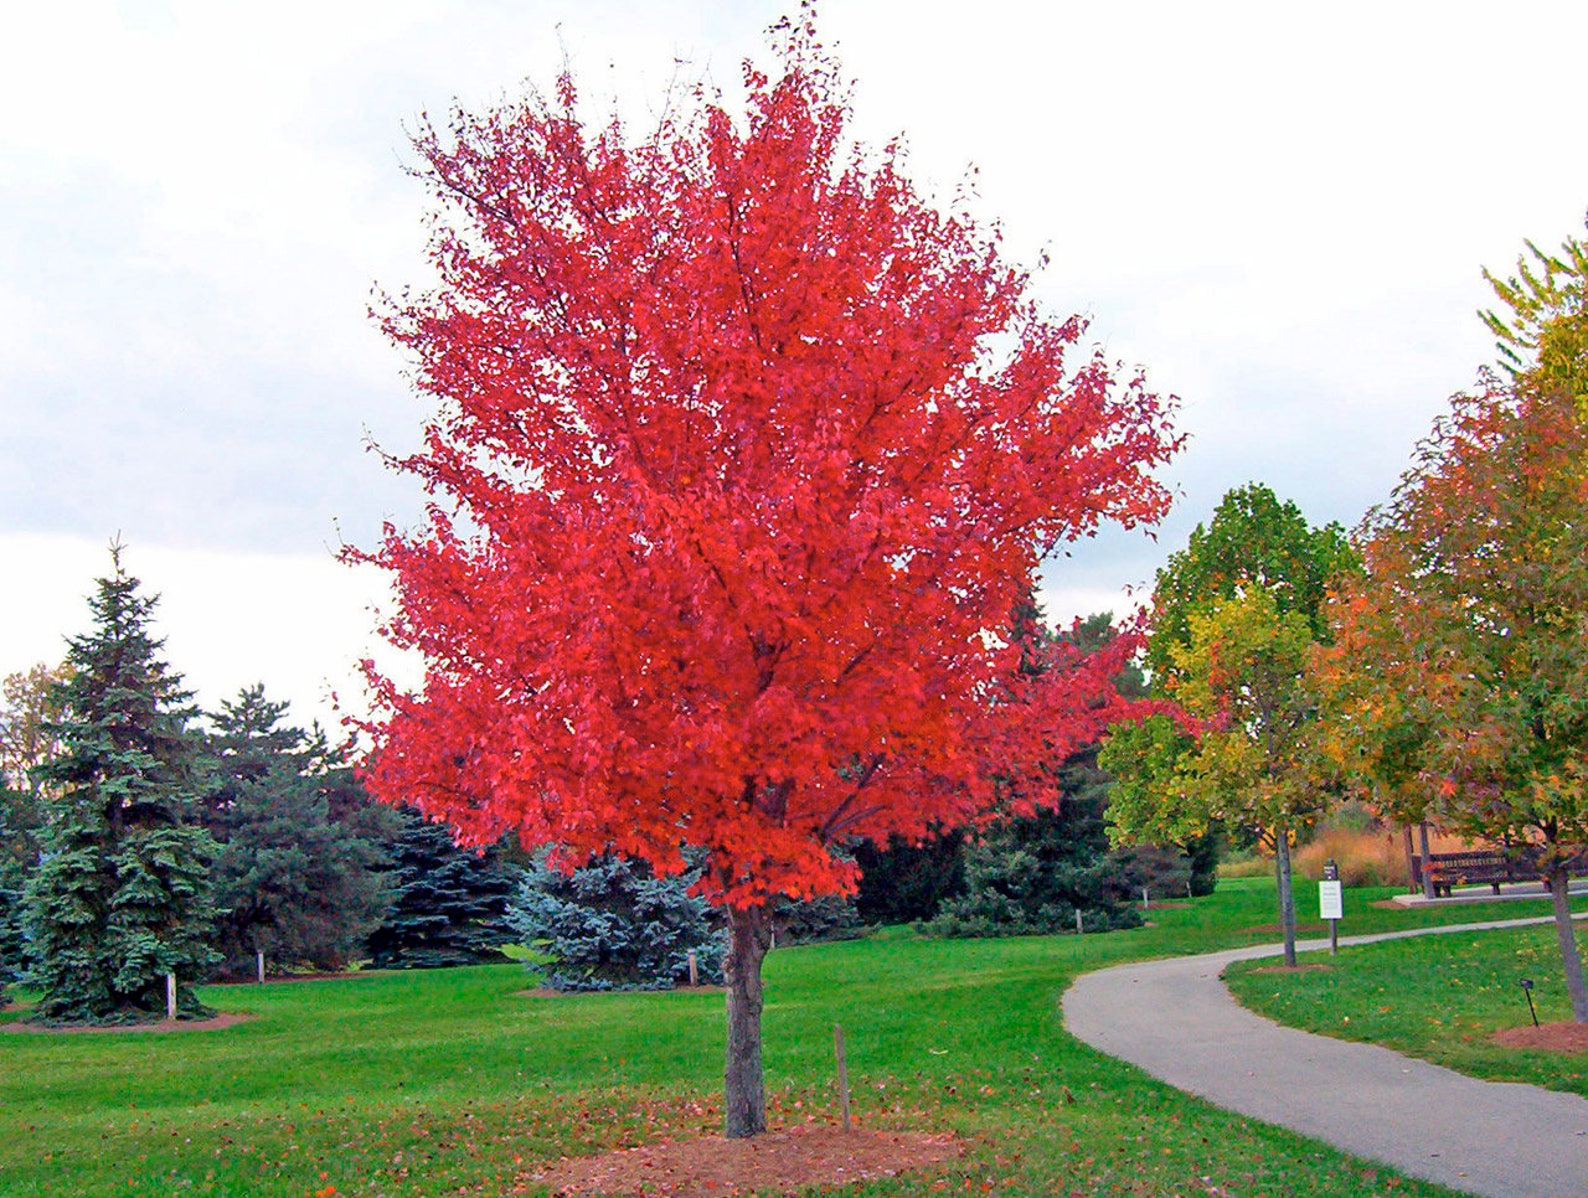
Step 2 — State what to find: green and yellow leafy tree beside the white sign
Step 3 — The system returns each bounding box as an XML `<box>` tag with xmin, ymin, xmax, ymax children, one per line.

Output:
<box><xmin>1100</xmin><ymin>483</ymin><xmax>1361</xmax><ymax>963</ymax></box>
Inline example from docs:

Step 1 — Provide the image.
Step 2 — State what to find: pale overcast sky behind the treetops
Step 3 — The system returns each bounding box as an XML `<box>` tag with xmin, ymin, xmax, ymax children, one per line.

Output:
<box><xmin>0</xmin><ymin>0</ymin><xmax>1588</xmax><ymax>721</ymax></box>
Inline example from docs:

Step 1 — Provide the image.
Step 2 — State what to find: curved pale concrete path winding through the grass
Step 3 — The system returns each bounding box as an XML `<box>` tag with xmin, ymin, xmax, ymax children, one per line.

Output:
<box><xmin>1064</xmin><ymin>917</ymin><xmax>1588</xmax><ymax>1198</ymax></box>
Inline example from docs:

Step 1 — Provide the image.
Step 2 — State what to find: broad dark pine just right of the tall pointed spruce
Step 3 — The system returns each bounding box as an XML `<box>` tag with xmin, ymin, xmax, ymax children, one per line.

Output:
<box><xmin>205</xmin><ymin>686</ymin><xmax>386</xmax><ymax>977</ymax></box>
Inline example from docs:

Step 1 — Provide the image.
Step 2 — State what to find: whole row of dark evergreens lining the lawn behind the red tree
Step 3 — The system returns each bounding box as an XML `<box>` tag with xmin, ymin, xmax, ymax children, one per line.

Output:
<box><xmin>0</xmin><ymin>550</ymin><xmax>1210</xmax><ymax>1023</ymax></box>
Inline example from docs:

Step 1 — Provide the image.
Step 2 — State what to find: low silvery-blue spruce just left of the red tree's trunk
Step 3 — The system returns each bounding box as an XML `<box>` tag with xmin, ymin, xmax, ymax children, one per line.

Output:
<box><xmin>511</xmin><ymin>852</ymin><xmax>726</xmax><ymax>990</ymax></box>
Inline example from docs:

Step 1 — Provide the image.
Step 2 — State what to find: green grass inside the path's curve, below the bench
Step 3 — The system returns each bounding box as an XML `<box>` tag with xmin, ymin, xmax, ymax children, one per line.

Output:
<box><xmin>1226</xmin><ymin>902</ymin><xmax>1588</xmax><ymax>1098</ymax></box>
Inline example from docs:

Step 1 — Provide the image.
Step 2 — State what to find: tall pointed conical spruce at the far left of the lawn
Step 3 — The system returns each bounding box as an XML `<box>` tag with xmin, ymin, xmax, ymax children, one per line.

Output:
<box><xmin>27</xmin><ymin>545</ymin><xmax>214</xmax><ymax>1023</ymax></box>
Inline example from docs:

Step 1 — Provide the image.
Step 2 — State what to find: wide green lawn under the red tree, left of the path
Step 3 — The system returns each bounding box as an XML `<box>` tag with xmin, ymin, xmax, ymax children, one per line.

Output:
<box><xmin>0</xmin><ymin>880</ymin><xmax>1548</xmax><ymax>1196</ymax></box>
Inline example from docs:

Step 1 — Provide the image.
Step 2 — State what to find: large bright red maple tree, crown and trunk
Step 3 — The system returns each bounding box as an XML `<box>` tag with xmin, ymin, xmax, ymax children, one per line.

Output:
<box><xmin>353</xmin><ymin>25</ymin><xmax>1177</xmax><ymax>1136</ymax></box>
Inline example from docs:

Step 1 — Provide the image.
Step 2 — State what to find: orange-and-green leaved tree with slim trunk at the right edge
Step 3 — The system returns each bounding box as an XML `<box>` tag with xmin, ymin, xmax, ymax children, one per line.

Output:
<box><xmin>1326</xmin><ymin>377</ymin><xmax>1588</xmax><ymax>1023</ymax></box>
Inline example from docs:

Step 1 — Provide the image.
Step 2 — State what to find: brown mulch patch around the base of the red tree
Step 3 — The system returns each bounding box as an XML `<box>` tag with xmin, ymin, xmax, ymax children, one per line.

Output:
<box><xmin>534</xmin><ymin>1127</ymin><xmax>961</xmax><ymax>1198</ymax></box>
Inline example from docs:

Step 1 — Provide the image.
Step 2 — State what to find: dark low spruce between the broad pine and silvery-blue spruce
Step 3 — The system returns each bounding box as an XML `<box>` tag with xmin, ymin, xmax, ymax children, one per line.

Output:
<box><xmin>368</xmin><ymin>810</ymin><xmax>516</xmax><ymax>969</ymax></box>
